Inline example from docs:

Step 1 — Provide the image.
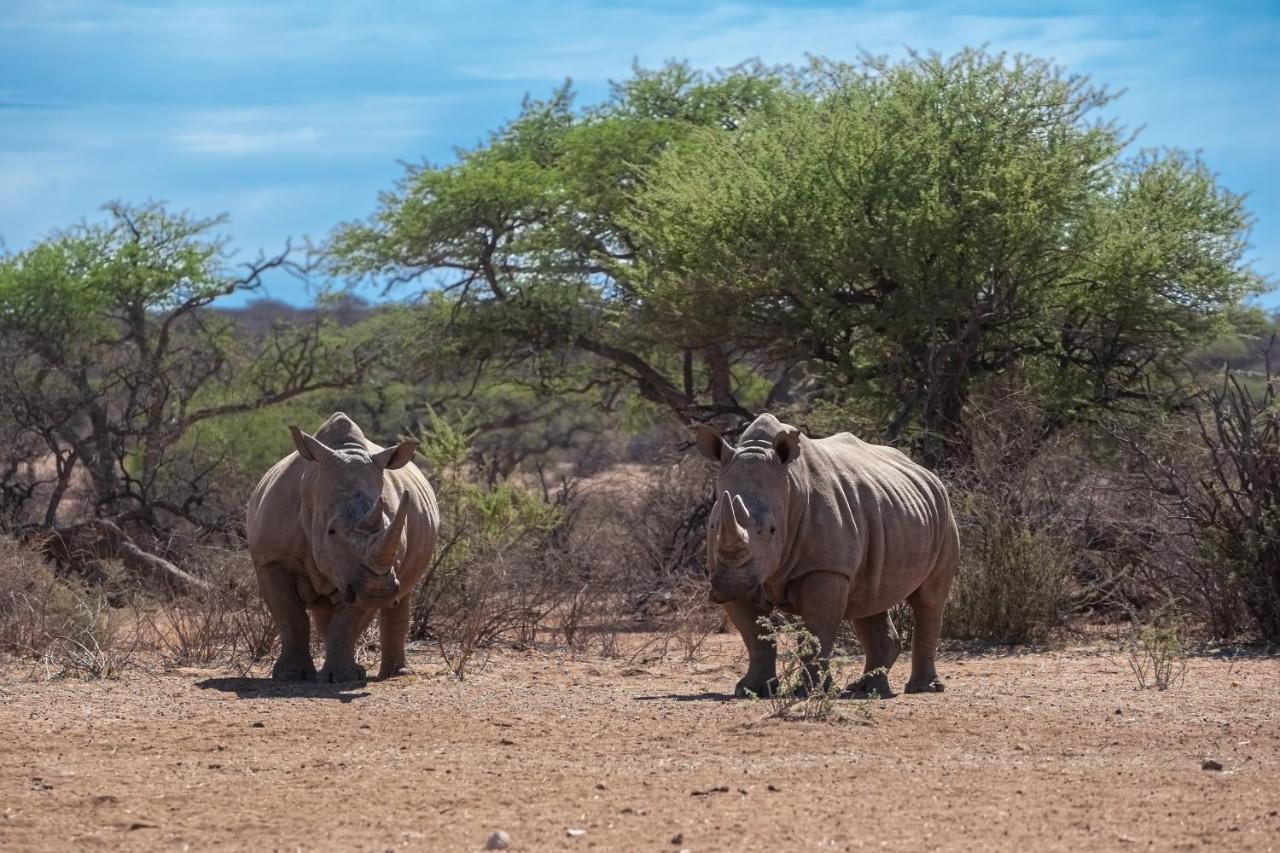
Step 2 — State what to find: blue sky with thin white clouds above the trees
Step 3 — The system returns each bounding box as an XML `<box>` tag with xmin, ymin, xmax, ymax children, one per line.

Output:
<box><xmin>0</xmin><ymin>0</ymin><xmax>1280</xmax><ymax>306</ymax></box>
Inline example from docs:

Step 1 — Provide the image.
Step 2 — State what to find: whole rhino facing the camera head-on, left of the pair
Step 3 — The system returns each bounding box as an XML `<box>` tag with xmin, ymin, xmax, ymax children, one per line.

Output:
<box><xmin>248</xmin><ymin>412</ymin><xmax>440</xmax><ymax>681</ymax></box>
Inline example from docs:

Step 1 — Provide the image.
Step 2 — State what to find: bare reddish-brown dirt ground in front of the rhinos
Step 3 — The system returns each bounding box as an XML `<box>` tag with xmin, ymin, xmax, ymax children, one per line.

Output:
<box><xmin>0</xmin><ymin>637</ymin><xmax>1280</xmax><ymax>852</ymax></box>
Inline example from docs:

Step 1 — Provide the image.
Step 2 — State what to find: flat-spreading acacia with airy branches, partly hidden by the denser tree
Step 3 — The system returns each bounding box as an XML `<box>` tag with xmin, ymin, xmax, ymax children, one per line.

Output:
<box><xmin>330</xmin><ymin>64</ymin><xmax>783</xmax><ymax>423</ymax></box>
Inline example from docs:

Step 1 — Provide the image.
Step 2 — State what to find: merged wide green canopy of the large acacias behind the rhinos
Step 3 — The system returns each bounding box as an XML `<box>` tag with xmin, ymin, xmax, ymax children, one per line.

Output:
<box><xmin>332</xmin><ymin>51</ymin><xmax>1262</xmax><ymax>462</ymax></box>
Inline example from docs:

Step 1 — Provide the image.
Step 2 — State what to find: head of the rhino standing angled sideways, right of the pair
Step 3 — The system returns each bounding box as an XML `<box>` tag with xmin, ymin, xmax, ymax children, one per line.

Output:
<box><xmin>696</xmin><ymin>415</ymin><xmax>800</xmax><ymax>606</ymax></box>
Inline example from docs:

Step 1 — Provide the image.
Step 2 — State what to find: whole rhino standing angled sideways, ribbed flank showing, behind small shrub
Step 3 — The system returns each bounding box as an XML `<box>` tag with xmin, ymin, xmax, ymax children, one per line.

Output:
<box><xmin>696</xmin><ymin>414</ymin><xmax>960</xmax><ymax>697</ymax></box>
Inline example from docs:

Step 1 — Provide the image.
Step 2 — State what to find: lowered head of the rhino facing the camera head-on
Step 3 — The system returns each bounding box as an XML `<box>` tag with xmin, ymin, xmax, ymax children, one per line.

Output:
<box><xmin>289</xmin><ymin>424</ymin><xmax>417</xmax><ymax>606</ymax></box>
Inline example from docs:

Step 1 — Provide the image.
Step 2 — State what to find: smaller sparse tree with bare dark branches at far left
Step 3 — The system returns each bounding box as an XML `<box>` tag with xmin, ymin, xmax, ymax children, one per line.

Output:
<box><xmin>0</xmin><ymin>204</ymin><xmax>369</xmax><ymax>535</ymax></box>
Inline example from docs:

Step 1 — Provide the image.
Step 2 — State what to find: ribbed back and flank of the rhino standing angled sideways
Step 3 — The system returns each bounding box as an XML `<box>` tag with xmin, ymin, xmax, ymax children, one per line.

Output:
<box><xmin>771</xmin><ymin>433</ymin><xmax>955</xmax><ymax>616</ymax></box>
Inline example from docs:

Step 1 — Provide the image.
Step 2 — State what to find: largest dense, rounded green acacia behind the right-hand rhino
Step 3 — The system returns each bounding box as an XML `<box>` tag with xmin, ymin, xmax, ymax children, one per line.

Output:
<box><xmin>626</xmin><ymin>51</ymin><xmax>1261</xmax><ymax>464</ymax></box>
